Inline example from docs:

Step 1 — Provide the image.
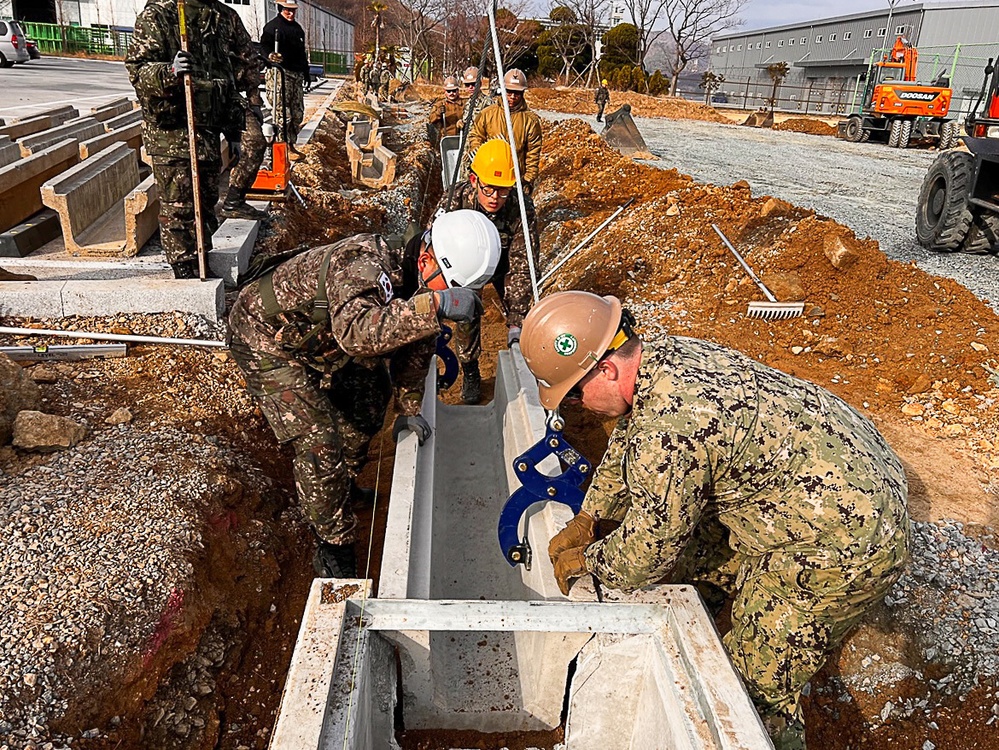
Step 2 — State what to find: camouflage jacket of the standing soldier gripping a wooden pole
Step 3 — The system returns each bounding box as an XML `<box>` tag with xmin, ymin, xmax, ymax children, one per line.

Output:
<box><xmin>125</xmin><ymin>0</ymin><xmax>261</xmax><ymax>156</ymax></box>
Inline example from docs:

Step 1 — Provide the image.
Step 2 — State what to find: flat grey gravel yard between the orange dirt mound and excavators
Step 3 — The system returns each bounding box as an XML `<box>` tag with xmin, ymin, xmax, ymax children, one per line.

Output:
<box><xmin>542</xmin><ymin>112</ymin><xmax>999</xmax><ymax>310</ymax></box>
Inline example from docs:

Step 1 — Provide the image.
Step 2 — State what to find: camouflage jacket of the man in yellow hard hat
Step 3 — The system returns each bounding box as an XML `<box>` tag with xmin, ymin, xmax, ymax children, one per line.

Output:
<box><xmin>434</xmin><ymin>185</ymin><xmax>540</xmax><ymax>320</ymax></box>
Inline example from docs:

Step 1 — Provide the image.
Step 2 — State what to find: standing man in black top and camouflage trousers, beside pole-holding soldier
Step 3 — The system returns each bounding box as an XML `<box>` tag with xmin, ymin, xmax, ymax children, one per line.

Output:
<box><xmin>260</xmin><ymin>0</ymin><xmax>309</xmax><ymax>156</ymax></box>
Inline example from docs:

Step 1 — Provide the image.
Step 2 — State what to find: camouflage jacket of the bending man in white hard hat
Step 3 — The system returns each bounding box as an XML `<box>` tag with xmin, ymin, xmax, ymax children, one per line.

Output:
<box><xmin>229</xmin><ymin>234</ymin><xmax>440</xmax><ymax>415</ymax></box>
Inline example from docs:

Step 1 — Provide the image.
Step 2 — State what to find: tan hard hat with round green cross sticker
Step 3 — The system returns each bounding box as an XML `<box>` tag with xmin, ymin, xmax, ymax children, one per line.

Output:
<box><xmin>520</xmin><ymin>292</ymin><xmax>622</xmax><ymax>410</ymax></box>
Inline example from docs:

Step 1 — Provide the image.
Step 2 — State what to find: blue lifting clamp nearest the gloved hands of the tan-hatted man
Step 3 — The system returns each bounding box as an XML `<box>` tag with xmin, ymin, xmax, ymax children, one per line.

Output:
<box><xmin>498</xmin><ymin>411</ymin><xmax>592</xmax><ymax>570</ymax></box>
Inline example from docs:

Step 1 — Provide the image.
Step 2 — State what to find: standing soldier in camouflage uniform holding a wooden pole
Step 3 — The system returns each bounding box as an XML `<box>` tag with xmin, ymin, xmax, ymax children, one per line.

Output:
<box><xmin>125</xmin><ymin>0</ymin><xmax>257</xmax><ymax>278</ymax></box>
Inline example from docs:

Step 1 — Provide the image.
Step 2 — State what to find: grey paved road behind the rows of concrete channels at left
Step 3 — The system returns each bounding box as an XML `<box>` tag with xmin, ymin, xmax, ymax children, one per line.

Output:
<box><xmin>0</xmin><ymin>57</ymin><xmax>135</xmax><ymax>120</ymax></box>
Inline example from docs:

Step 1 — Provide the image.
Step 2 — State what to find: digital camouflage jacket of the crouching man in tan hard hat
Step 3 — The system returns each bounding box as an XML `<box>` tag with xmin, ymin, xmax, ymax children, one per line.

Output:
<box><xmin>583</xmin><ymin>338</ymin><xmax>909</xmax><ymax>590</ymax></box>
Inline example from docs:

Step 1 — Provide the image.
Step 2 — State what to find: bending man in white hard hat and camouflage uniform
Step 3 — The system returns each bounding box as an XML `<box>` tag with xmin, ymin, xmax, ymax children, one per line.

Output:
<box><xmin>229</xmin><ymin>211</ymin><xmax>500</xmax><ymax>578</ymax></box>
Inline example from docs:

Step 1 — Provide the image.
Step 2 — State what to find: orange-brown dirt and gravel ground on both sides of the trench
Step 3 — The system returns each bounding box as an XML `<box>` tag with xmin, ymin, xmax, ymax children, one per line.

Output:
<box><xmin>0</xmin><ymin>87</ymin><xmax>999</xmax><ymax>750</ymax></box>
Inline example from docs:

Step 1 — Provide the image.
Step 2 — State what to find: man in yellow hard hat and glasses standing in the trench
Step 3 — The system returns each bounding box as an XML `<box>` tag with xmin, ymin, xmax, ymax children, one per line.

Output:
<box><xmin>437</xmin><ymin>138</ymin><xmax>539</xmax><ymax>404</ymax></box>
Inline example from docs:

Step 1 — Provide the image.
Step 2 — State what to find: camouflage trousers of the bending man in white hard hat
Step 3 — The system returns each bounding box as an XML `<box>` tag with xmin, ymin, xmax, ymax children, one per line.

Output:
<box><xmin>230</xmin><ymin>336</ymin><xmax>392</xmax><ymax>544</ymax></box>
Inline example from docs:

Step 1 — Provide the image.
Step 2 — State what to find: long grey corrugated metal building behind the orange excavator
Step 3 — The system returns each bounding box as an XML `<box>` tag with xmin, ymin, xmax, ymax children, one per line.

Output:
<box><xmin>711</xmin><ymin>0</ymin><xmax>999</xmax><ymax>116</ymax></box>
